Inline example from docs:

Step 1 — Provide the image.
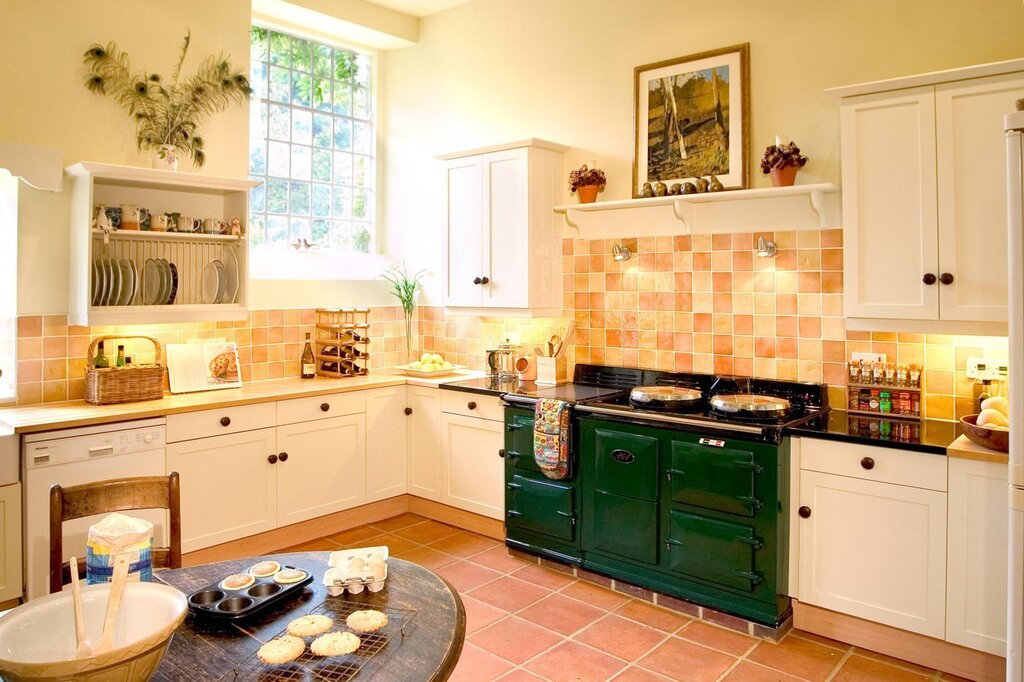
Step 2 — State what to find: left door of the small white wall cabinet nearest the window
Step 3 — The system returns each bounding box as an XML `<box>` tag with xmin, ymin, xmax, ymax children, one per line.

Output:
<box><xmin>444</xmin><ymin>157</ymin><xmax>484</xmax><ymax>306</ymax></box>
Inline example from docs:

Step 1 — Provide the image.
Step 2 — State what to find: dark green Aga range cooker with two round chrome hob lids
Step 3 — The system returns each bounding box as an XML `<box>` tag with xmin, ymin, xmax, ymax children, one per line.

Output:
<box><xmin>505</xmin><ymin>366</ymin><xmax>827</xmax><ymax>625</ymax></box>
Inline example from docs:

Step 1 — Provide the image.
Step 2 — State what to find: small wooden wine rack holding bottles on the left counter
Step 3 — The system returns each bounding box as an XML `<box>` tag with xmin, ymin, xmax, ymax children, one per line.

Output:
<box><xmin>313</xmin><ymin>308</ymin><xmax>370</xmax><ymax>379</ymax></box>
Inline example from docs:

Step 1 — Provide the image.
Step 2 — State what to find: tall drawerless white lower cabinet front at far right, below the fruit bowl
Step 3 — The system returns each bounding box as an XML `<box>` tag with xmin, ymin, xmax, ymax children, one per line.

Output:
<box><xmin>946</xmin><ymin>457</ymin><xmax>1009</xmax><ymax>656</ymax></box>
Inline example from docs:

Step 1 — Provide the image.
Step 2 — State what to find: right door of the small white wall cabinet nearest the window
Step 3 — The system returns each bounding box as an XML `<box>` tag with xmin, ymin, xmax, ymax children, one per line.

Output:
<box><xmin>481</xmin><ymin>147</ymin><xmax>528</xmax><ymax>308</ymax></box>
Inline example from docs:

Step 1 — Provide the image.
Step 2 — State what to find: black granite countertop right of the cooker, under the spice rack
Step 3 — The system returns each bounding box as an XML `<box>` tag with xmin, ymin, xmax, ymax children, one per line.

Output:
<box><xmin>786</xmin><ymin>410</ymin><xmax>961</xmax><ymax>455</ymax></box>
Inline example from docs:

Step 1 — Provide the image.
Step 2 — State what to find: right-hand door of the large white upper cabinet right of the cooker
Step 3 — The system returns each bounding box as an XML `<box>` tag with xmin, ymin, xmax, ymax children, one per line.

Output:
<box><xmin>935</xmin><ymin>74</ymin><xmax>1024</xmax><ymax>322</ymax></box>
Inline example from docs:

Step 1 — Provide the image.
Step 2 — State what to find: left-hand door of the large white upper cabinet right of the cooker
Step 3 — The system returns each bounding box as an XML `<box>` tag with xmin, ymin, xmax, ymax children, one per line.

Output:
<box><xmin>840</xmin><ymin>86</ymin><xmax>941</xmax><ymax>319</ymax></box>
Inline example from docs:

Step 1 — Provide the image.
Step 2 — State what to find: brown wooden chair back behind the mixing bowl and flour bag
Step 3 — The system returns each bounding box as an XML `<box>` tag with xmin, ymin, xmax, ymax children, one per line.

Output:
<box><xmin>50</xmin><ymin>471</ymin><xmax>181</xmax><ymax>593</ymax></box>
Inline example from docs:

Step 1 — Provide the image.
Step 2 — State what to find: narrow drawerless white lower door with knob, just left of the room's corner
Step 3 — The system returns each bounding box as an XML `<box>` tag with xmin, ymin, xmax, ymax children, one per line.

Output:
<box><xmin>366</xmin><ymin>386</ymin><xmax>412</xmax><ymax>502</ymax></box>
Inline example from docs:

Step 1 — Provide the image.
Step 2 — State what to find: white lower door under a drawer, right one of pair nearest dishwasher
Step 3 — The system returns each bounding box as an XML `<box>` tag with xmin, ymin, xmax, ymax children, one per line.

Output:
<box><xmin>276</xmin><ymin>415</ymin><xmax>367</xmax><ymax>525</ymax></box>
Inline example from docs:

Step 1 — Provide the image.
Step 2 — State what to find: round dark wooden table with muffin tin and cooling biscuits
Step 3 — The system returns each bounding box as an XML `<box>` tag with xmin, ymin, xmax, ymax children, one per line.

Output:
<box><xmin>153</xmin><ymin>552</ymin><xmax>466</xmax><ymax>682</ymax></box>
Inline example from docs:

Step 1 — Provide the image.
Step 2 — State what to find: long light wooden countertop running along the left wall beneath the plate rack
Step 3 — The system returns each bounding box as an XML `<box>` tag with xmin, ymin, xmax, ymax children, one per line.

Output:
<box><xmin>0</xmin><ymin>370</ymin><xmax>482</xmax><ymax>434</ymax></box>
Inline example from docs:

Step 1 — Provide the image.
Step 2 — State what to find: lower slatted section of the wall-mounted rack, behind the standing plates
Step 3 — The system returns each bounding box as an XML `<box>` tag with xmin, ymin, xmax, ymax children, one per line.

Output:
<box><xmin>89</xmin><ymin>229</ymin><xmax>239</xmax><ymax>309</ymax></box>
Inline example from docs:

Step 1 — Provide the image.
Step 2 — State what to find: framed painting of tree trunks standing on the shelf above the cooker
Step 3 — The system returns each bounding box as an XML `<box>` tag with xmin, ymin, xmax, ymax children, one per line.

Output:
<box><xmin>633</xmin><ymin>43</ymin><xmax>751</xmax><ymax>197</ymax></box>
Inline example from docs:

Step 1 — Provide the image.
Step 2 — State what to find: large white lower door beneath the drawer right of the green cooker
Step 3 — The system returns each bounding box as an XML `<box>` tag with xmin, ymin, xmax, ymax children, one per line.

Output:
<box><xmin>796</xmin><ymin>466</ymin><xmax>946</xmax><ymax>639</ymax></box>
